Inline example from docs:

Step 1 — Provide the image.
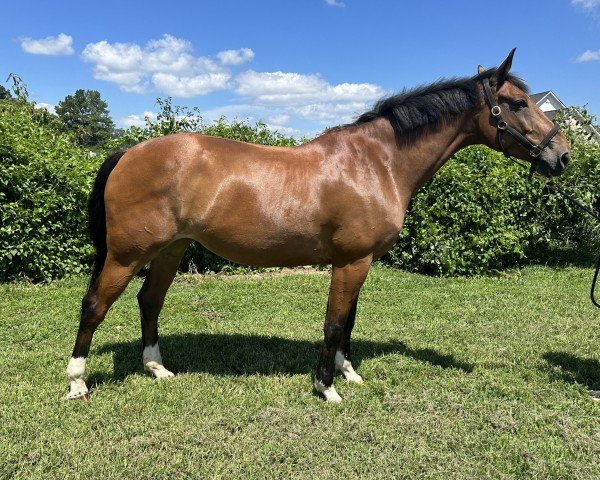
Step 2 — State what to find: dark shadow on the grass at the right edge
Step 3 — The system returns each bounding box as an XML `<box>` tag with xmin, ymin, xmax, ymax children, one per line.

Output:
<box><xmin>542</xmin><ymin>352</ymin><xmax>600</xmax><ymax>397</ymax></box>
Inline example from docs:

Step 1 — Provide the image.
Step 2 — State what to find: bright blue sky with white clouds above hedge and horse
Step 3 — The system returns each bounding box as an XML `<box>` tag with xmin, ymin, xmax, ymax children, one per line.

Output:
<box><xmin>0</xmin><ymin>0</ymin><xmax>600</xmax><ymax>135</ymax></box>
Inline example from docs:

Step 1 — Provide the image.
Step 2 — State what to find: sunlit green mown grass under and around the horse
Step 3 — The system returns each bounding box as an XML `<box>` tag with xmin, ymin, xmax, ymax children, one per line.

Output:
<box><xmin>0</xmin><ymin>267</ymin><xmax>600</xmax><ymax>479</ymax></box>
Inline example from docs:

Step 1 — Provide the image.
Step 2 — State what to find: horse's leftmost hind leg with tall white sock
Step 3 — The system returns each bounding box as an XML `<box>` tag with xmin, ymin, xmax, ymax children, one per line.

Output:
<box><xmin>66</xmin><ymin>252</ymin><xmax>143</xmax><ymax>400</ymax></box>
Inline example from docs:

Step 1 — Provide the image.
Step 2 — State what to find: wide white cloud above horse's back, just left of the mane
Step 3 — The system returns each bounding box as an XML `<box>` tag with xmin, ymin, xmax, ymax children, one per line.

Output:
<box><xmin>236</xmin><ymin>70</ymin><xmax>386</xmax><ymax>125</ymax></box>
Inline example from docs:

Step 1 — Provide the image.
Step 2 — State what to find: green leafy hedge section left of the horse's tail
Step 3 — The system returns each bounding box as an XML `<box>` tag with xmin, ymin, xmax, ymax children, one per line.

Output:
<box><xmin>0</xmin><ymin>97</ymin><xmax>99</xmax><ymax>281</ymax></box>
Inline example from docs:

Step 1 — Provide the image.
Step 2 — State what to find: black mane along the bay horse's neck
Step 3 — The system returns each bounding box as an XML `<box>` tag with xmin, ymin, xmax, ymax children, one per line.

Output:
<box><xmin>338</xmin><ymin>68</ymin><xmax>529</xmax><ymax>145</ymax></box>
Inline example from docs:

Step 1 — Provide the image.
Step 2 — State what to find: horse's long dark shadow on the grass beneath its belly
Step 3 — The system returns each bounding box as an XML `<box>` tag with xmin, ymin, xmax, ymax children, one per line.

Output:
<box><xmin>89</xmin><ymin>333</ymin><xmax>473</xmax><ymax>385</ymax></box>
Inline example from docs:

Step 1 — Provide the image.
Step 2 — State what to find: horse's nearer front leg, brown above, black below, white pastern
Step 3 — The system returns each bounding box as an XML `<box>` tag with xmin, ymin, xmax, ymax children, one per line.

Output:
<box><xmin>314</xmin><ymin>256</ymin><xmax>372</xmax><ymax>403</ymax></box>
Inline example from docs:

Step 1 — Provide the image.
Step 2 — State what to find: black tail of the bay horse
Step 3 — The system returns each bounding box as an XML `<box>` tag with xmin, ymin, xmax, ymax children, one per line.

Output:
<box><xmin>88</xmin><ymin>152</ymin><xmax>125</xmax><ymax>288</ymax></box>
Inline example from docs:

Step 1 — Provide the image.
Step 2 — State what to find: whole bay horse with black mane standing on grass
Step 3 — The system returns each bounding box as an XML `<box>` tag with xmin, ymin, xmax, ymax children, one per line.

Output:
<box><xmin>67</xmin><ymin>49</ymin><xmax>569</xmax><ymax>402</ymax></box>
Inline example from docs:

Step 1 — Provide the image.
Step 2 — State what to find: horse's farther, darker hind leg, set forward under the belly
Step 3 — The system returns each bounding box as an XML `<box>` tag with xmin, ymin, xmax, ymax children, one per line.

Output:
<box><xmin>137</xmin><ymin>239</ymin><xmax>191</xmax><ymax>379</ymax></box>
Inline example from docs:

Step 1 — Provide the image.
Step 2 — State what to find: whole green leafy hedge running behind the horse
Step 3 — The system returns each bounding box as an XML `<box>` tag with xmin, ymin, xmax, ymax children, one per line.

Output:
<box><xmin>0</xmin><ymin>94</ymin><xmax>600</xmax><ymax>281</ymax></box>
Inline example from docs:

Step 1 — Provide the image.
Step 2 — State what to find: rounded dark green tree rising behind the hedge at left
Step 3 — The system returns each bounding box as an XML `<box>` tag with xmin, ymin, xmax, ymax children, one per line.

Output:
<box><xmin>56</xmin><ymin>89</ymin><xmax>115</xmax><ymax>147</ymax></box>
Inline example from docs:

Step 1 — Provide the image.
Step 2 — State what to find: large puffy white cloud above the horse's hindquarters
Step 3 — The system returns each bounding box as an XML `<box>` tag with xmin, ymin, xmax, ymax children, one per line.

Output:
<box><xmin>82</xmin><ymin>34</ymin><xmax>231</xmax><ymax>98</ymax></box>
